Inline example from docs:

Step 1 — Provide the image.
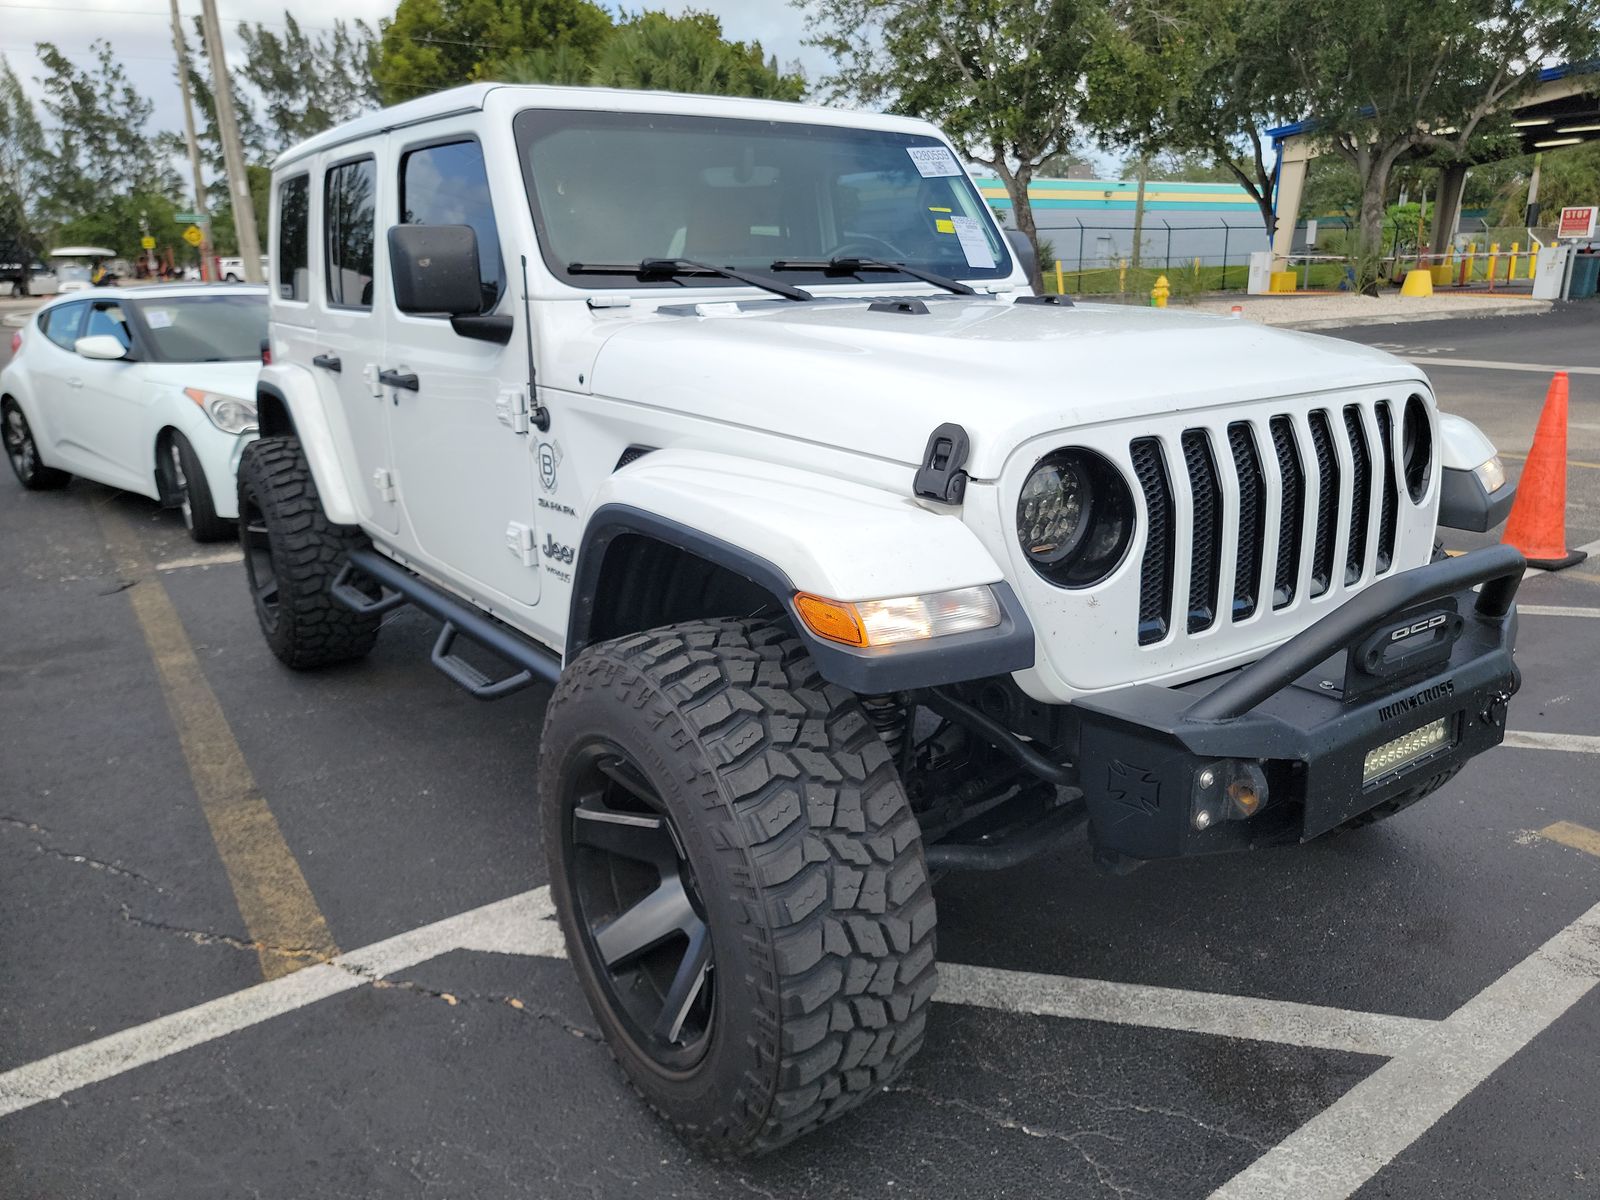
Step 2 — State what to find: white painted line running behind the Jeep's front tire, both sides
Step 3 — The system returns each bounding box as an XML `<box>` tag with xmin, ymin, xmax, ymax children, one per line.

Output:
<box><xmin>0</xmin><ymin>888</ymin><xmax>1437</xmax><ymax>1117</ymax></box>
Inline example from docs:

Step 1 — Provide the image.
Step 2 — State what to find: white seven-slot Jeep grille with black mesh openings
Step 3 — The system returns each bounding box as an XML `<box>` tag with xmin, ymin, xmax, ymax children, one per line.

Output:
<box><xmin>1128</xmin><ymin>400</ymin><xmax>1400</xmax><ymax>645</ymax></box>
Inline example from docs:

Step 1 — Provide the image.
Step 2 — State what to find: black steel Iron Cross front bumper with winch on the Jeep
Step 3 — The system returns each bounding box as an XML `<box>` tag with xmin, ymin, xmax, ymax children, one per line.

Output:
<box><xmin>1072</xmin><ymin>546</ymin><xmax>1525</xmax><ymax>859</ymax></box>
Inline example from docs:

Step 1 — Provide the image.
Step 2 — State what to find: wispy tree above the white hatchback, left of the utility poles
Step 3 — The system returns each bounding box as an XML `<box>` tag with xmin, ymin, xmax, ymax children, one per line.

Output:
<box><xmin>37</xmin><ymin>40</ymin><xmax>178</xmax><ymax>235</ymax></box>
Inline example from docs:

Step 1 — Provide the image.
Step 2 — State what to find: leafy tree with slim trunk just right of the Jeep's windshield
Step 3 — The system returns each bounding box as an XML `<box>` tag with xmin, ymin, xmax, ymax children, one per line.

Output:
<box><xmin>797</xmin><ymin>0</ymin><xmax>1106</xmax><ymax>288</ymax></box>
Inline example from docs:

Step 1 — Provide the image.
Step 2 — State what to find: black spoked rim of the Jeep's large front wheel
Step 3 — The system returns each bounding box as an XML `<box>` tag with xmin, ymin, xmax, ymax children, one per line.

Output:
<box><xmin>566</xmin><ymin>738</ymin><xmax>715</xmax><ymax>1072</ymax></box>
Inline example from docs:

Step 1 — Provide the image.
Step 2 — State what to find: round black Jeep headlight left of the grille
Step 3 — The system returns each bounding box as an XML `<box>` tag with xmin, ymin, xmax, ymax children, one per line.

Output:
<box><xmin>1016</xmin><ymin>450</ymin><xmax>1133</xmax><ymax>587</ymax></box>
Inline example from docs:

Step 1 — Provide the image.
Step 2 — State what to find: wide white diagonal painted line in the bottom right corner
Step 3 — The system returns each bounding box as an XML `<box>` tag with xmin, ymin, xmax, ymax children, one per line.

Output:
<box><xmin>1211</xmin><ymin>904</ymin><xmax>1600</xmax><ymax>1200</ymax></box>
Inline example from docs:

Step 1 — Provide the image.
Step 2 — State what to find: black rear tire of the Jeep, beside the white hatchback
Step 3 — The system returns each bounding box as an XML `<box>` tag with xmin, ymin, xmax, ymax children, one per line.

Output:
<box><xmin>238</xmin><ymin>437</ymin><xmax>379</xmax><ymax>670</ymax></box>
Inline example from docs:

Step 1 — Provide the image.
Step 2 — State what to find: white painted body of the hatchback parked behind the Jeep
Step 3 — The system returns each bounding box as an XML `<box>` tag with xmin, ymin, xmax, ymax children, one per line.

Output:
<box><xmin>0</xmin><ymin>285</ymin><xmax>261</xmax><ymax>520</ymax></box>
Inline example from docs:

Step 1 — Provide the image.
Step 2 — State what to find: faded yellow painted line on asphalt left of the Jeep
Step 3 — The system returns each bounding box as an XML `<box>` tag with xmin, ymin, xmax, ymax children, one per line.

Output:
<box><xmin>99</xmin><ymin>507</ymin><xmax>339</xmax><ymax>979</ymax></box>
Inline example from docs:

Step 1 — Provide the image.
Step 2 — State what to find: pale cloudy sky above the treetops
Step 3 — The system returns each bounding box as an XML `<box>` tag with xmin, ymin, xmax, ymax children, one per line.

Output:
<box><xmin>0</xmin><ymin>0</ymin><xmax>827</xmax><ymax>138</ymax></box>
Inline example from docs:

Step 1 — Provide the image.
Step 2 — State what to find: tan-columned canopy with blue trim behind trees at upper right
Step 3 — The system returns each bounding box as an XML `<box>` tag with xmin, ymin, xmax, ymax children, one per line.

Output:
<box><xmin>1267</xmin><ymin>62</ymin><xmax>1600</xmax><ymax>264</ymax></box>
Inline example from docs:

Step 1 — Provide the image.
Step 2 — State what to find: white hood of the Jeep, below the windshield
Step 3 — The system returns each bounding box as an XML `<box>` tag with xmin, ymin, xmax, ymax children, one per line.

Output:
<box><xmin>594</xmin><ymin>296</ymin><xmax>1422</xmax><ymax>478</ymax></box>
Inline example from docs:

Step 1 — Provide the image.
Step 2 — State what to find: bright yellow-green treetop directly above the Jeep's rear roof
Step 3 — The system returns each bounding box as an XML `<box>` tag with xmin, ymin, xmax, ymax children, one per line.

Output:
<box><xmin>373</xmin><ymin>0</ymin><xmax>613</xmax><ymax>104</ymax></box>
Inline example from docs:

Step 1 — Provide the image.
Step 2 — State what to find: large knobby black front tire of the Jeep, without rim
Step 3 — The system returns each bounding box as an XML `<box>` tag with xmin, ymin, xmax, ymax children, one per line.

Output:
<box><xmin>539</xmin><ymin>619</ymin><xmax>936</xmax><ymax>1157</ymax></box>
